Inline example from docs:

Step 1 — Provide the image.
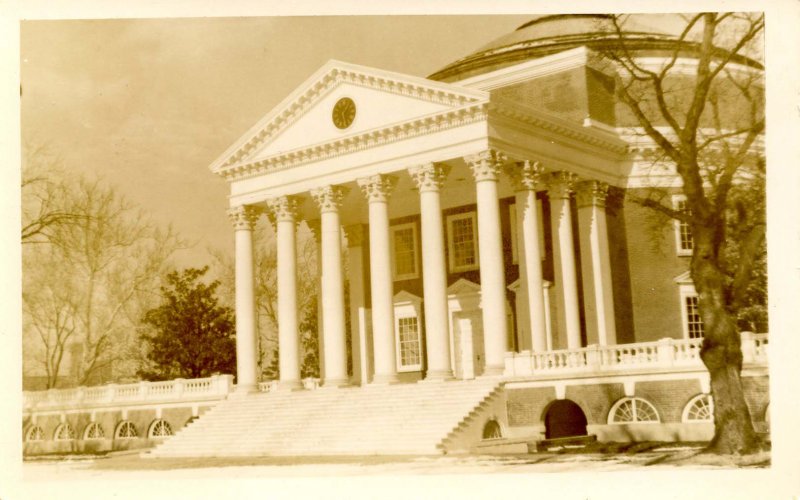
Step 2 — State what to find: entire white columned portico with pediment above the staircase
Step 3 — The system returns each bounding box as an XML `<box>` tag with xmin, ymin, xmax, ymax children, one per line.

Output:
<box><xmin>212</xmin><ymin>61</ymin><xmax>625</xmax><ymax>391</ymax></box>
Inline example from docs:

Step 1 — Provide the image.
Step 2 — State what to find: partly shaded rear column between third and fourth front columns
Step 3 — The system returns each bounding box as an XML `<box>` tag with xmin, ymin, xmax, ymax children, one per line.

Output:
<box><xmin>344</xmin><ymin>224</ymin><xmax>370</xmax><ymax>385</ymax></box>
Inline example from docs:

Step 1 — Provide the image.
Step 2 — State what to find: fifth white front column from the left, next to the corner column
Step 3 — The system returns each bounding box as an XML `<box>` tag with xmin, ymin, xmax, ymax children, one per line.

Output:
<box><xmin>408</xmin><ymin>163</ymin><xmax>453</xmax><ymax>380</ymax></box>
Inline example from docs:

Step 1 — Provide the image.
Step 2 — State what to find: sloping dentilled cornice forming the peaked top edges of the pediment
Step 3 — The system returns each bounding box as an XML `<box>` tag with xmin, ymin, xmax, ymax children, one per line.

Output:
<box><xmin>211</xmin><ymin>61</ymin><xmax>487</xmax><ymax>173</ymax></box>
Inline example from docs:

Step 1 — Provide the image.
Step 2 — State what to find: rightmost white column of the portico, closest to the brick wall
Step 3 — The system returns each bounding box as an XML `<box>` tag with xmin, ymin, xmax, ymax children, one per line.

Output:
<box><xmin>576</xmin><ymin>181</ymin><xmax>617</xmax><ymax>345</ymax></box>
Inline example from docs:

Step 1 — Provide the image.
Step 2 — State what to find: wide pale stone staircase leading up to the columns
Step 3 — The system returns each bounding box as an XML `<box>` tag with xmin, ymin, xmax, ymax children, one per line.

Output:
<box><xmin>147</xmin><ymin>379</ymin><xmax>502</xmax><ymax>458</ymax></box>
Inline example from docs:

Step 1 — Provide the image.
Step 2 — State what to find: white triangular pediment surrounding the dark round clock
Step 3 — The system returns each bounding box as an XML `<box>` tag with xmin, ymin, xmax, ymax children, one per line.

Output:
<box><xmin>211</xmin><ymin>61</ymin><xmax>488</xmax><ymax>172</ymax></box>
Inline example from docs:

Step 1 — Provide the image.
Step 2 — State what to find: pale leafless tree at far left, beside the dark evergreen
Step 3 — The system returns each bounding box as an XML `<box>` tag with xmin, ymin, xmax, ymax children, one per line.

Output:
<box><xmin>23</xmin><ymin>163</ymin><xmax>184</xmax><ymax>387</ymax></box>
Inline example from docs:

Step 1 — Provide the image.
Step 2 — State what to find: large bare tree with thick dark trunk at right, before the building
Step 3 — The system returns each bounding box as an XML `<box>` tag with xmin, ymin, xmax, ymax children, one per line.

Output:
<box><xmin>604</xmin><ymin>13</ymin><xmax>766</xmax><ymax>453</ymax></box>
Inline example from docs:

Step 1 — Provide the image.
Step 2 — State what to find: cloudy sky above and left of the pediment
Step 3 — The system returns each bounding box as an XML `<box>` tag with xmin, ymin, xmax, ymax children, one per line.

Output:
<box><xmin>20</xmin><ymin>16</ymin><xmax>531</xmax><ymax>265</ymax></box>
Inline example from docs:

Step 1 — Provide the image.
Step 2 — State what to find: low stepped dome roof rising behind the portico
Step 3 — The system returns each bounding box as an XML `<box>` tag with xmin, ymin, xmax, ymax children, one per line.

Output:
<box><xmin>428</xmin><ymin>14</ymin><xmax>758</xmax><ymax>81</ymax></box>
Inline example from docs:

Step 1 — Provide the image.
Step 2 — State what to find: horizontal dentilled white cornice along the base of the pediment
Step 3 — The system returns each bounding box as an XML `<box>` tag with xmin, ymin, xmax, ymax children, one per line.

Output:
<box><xmin>217</xmin><ymin>102</ymin><xmax>488</xmax><ymax>181</ymax></box>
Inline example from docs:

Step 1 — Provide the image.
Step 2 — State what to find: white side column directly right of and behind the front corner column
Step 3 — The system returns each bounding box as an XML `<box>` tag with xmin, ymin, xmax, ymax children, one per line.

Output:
<box><xmin>508</xmin><ymin>161</ymin><xmax>547</xmax><ymax>352</ymax></box>
